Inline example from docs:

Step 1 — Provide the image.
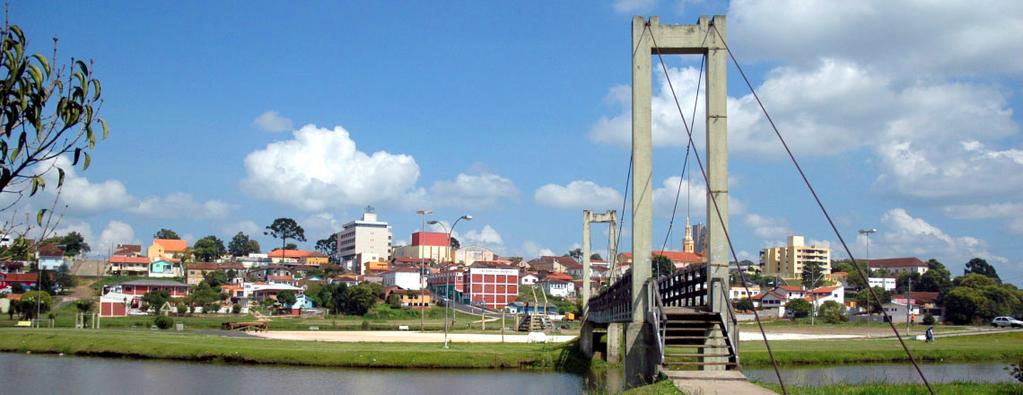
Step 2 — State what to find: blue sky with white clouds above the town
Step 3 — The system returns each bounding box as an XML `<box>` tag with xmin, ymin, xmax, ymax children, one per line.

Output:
<box><xmin>8</xmin><ymin>0</ymin><xmax>1023</xmax><ymax>283</ymax></box>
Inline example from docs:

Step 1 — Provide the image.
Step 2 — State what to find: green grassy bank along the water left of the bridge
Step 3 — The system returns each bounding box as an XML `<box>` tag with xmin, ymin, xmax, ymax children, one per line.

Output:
<box><xmin>0</xmin><ymin>328</ymin><xmax>574</xmax><ymax>369</ymax></box>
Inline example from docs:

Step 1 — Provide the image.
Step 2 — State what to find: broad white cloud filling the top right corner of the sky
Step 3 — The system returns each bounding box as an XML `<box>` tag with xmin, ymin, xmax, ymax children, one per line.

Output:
<box><xmin>728</xmin><ymin>0</ymin><xmax>1023</xmax><ymax>75</ymax></box>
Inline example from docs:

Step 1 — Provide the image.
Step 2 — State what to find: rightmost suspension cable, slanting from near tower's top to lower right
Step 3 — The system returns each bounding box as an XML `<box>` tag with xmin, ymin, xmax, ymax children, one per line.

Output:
<box><xmin>712</xmin><ymin>26</ymin><xmax>935</xmax><ymax>395</ymax></box>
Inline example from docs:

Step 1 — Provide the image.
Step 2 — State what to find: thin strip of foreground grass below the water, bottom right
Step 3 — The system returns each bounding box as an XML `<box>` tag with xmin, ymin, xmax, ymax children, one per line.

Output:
<box><xmin>758</xmin><ymin>383</ymin><xmax>1023</xmax><ymax>395</ymax></box>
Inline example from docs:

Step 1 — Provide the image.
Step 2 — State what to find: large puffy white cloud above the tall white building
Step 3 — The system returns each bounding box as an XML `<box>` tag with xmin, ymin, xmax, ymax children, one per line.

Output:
<box><xmin>241</xmin><ymin>125</ymin><xmax>419</xmax><ymax>211</ymax></box>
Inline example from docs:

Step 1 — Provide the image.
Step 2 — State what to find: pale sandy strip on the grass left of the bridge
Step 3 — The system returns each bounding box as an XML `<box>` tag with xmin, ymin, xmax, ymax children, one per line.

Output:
<box><xmin>253</xmin><ymin>331</ymin><xmax>575</xmax><ymax>343</ymax></box>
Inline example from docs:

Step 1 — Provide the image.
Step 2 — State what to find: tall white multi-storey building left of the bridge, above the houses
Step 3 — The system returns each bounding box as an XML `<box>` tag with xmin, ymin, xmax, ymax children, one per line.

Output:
<box><xmin>338</xmin><ymin>207</ymin><xmax>391</xmax><ymax>274</ymax></box>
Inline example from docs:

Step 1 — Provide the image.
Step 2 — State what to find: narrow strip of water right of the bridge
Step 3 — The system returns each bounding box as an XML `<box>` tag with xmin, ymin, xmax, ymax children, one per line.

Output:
<box><xmin>743</xmin><ymin>362</ymin><xmax>1016</xmax><ymax>386</ymax></box>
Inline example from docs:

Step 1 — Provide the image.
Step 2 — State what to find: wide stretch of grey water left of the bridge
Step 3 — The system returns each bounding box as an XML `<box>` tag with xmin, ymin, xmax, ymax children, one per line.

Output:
<box><xmin>0</xmin><ymin>353</ymin><xmax>583</xmax><ymax>395</ymax></box>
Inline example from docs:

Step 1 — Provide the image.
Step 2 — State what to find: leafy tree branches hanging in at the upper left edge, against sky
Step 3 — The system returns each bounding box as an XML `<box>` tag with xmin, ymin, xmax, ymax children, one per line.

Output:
<box><xmin>0</xmin><ymin>24</ymin><xmax>109</xmax><ymax>218</ymax></box>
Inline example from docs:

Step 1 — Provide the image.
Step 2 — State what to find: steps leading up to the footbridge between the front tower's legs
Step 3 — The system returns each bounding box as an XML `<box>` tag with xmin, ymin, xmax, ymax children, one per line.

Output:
<box><xmin>661</xmin><ymin>307</ymin><xmax>740</xmax><ymax>371</ymax></box>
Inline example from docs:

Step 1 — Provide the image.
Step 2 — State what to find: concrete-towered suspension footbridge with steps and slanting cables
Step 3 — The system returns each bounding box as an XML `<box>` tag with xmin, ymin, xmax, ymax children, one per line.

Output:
<box><xmin>579</xmin><ymin>15</ymin><xmax>934</xmax><ymax>394</ymax></box>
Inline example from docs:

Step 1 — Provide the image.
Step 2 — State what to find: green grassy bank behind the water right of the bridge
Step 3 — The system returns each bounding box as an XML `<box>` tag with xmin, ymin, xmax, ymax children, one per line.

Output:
<box><xmin>740</xmin><ymin>333</ymin><xmax>1023</xmax><ymax>367</ymax></box>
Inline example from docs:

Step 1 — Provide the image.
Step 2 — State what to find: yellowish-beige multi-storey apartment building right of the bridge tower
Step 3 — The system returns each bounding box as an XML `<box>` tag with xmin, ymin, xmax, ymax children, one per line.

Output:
<box><xmin>760</xmin><ymin>235</ymin><xmax>831</xmax><ymax>281</ymax></box>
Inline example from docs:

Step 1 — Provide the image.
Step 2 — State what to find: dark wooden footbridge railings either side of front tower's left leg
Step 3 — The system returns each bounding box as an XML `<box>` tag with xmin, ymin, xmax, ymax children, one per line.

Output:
<box><xmin>586</xmin><ymin>264</ymin><xmax>708</xmax><ymax>323</ymax></box>
